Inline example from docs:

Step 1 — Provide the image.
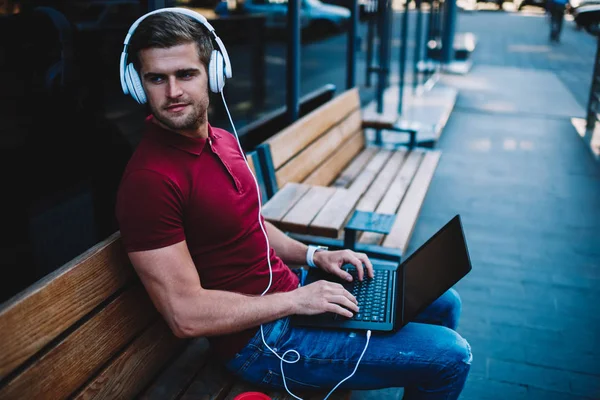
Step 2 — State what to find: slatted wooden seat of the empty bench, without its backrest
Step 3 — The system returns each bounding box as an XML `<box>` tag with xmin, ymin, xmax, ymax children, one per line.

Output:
<box><xmin>263</xmin><ymin>147</ymin><xmax>441</xmax><ymax>252</ymax></box>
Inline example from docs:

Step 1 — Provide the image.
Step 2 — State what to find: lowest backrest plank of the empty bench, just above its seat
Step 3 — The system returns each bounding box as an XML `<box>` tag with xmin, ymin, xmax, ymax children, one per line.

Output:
<box><xmin>302</xmin><ymin>130</ymin><xmax>365</xmax><ymax>186</ymax></box>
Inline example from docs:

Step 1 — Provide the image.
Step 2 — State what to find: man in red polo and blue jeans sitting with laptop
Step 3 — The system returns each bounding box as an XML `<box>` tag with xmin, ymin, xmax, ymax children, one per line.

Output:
<box><xmin>117</xmin><ymin>12</ymin><xmax>471</xmax><ymax>399</ymax></box>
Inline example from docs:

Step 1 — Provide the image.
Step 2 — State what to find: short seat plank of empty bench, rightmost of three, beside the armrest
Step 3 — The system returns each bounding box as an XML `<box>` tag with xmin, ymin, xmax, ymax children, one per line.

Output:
<box><xmin>308</xmin><ymin>188</ymin><xmax>360</xmax><ymax>238</ymax></box>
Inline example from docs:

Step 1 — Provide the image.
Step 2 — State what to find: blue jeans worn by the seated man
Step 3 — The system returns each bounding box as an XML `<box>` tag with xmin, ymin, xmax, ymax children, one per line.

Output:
<box><xmin>226</xmin><ymin>270</ymin><xmax>472</xmax><ymax>400</ymax></box>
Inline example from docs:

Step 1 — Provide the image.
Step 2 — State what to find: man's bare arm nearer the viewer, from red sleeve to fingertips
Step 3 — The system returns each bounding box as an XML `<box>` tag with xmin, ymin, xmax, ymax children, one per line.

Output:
<box><xmin>129</xmin><ymin>241</ymin><xmax>358</xmax><ymax>337</ymax></box>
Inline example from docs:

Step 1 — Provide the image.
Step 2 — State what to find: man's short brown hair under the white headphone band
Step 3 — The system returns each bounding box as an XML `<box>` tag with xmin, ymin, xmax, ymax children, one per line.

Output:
<box><xmin>128</xmin><ymin>11</ymin><xmax>214</xmax><ymax>72</ymax></box>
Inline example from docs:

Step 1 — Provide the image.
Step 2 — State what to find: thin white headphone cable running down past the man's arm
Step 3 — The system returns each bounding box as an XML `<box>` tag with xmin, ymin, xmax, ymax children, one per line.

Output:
<box><xmin>221</xmin><ymin>91</ymin><xmax>371</xmax><ymax>400</ymax></box>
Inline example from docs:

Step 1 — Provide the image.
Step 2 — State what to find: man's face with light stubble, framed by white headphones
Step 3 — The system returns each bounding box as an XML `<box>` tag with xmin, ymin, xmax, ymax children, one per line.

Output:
<box><xmin>139</xmin><ymin>43</ymin><xmax>209</xmax><ymax>135</ymax></box>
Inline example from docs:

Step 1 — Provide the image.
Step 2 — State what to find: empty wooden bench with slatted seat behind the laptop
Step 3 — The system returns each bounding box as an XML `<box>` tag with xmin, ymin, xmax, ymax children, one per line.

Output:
<box><xmin>257</xmin><ymin>88</ymin><xmax>441</xmax><ymax>258</ymax></box>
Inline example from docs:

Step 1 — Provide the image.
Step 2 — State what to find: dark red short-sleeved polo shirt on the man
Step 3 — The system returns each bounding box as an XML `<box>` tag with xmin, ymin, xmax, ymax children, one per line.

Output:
<box><xmin>116</xmin><ymin>117</ymin><xmax>298</xmax><ymax>358</ymax></box>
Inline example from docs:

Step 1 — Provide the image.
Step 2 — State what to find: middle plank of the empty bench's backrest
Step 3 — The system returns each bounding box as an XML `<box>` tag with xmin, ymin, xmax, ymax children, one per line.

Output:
<box><xmin>275</xmin><ymin>118</ymin><xmax>360</xmax><ymax>187</ymax></box>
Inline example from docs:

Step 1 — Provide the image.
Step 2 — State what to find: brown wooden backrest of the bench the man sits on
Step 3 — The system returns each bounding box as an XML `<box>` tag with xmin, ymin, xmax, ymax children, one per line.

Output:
<box><xmin>0</xmin><ymin>232</ymin><xmax>186</xmax><ymax>399</ymax></box>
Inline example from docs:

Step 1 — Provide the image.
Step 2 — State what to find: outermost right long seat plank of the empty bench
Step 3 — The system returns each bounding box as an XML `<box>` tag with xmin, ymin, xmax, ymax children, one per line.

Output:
<box><xmin>383</xmin><ymin>151</ymin><xmax>442</xmax><ymax>253</ymax></box>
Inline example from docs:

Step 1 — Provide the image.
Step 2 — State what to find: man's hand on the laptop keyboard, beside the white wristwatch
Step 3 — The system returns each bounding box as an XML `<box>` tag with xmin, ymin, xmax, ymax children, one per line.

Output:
<box><xmin>313</xmin><ymin>250</ymin><xmax>374</xmax><ymax>282</ymax></box>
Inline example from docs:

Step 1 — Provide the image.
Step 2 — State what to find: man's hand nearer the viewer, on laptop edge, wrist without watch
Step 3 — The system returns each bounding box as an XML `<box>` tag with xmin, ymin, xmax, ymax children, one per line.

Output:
<box><xmin>290</xmin><ymin>280</ymin><xmax>358</xmax><ymax>318</ymax></box>
